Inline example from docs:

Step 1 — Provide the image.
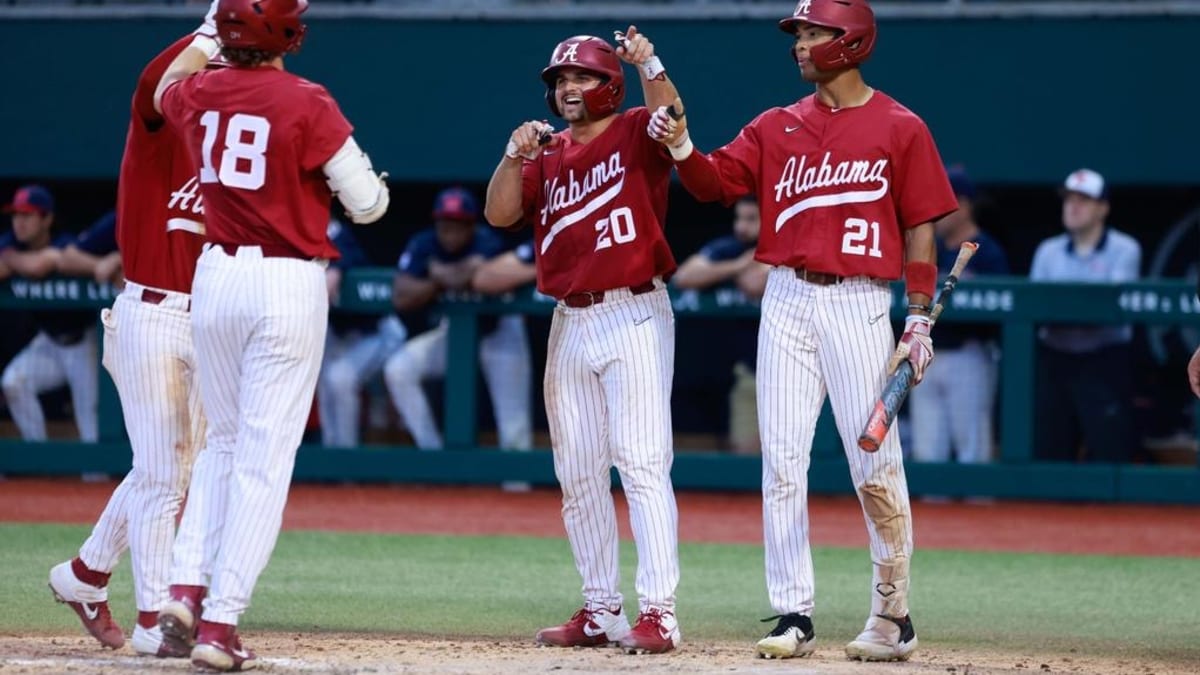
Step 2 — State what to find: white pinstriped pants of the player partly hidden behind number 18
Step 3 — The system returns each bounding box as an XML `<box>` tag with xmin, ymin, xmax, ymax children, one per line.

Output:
<box><xmin>79</xmin><ymin>281</ymin><xmax>204</xmax><ymax>611</ymax></box>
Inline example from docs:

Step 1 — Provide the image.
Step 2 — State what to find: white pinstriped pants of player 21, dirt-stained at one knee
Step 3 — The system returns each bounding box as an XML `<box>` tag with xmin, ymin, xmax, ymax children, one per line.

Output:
<box><xmin>757</xmin><ymin>268</ymin><xmax>912</xmax><ymax>616</ymax></box>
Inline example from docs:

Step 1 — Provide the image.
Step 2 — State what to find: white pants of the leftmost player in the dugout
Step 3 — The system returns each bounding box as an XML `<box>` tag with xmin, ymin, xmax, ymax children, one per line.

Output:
<box><xmin>0</xmin><ymin>328</ymin><xmax>100</xmax><ymax>443</ymax></box>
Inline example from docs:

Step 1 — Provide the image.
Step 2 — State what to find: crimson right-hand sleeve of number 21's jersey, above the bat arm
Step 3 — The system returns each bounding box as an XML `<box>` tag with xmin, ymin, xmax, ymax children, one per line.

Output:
<box><xmin>892</xmin><ymin>118</ymin><xmax>959</xmax><ymax>229</ymax></box>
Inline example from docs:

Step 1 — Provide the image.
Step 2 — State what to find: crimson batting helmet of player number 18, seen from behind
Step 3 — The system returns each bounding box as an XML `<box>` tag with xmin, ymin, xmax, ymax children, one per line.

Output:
<box><xmin>215</xmin><ymin>0</ymin><xmax>308</xmax><ymax>54</ymax></box>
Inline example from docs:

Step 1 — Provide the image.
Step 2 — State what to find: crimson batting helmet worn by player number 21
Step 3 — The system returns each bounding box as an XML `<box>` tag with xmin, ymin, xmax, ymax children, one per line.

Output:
<box><xmin>779</xmin><ymin>0</ymin><xmax>876</xmax><ymax>71</ymax></box>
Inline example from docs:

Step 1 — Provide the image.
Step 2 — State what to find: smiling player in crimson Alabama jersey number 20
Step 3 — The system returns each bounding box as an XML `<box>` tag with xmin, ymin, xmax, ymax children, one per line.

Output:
<box><xmin>485</xmin><ymin>26</ymin><xmax>680</xmax><ymax>652</ymax></box>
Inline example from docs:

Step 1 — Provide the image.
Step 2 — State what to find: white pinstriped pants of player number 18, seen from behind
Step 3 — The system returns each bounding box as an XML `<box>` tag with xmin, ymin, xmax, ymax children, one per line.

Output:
<box><xmin>172</xmin><ymin>246</ymin><xmax>329</xmax><ymax>623</ymax></box>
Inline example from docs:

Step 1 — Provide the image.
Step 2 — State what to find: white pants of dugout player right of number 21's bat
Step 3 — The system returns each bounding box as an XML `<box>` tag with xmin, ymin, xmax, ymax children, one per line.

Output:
<box><xmin>908</xmin><ymin>340</ymin><xmax>996</xmax><ymax>464</ymax></box>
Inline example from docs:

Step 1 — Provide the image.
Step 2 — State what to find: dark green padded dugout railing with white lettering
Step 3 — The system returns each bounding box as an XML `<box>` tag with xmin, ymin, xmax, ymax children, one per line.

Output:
<box><xmin>0</xmin><ymin>269</ymin><xmax>1200</xmax><ymax>503</ymax></box>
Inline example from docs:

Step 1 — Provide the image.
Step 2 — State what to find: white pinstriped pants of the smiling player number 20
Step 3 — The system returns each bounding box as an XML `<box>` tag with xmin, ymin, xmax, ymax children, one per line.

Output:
<box><xmin>545</xmin><ymin>282</ymin><xmax>679</xmax><ymax>610</ymax></box>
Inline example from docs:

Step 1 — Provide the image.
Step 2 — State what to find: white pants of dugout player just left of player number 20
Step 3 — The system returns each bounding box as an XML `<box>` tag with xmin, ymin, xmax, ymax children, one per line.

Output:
<box><xmin>384</xmin><ymin>315</ymin><xmax>533</xmax><ymax>450</ymax></box>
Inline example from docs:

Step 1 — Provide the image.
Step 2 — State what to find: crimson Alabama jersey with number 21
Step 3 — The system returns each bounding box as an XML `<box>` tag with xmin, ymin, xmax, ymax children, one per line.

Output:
<box><xmin>679</xmin><ymin>91</ymin><xmax>958</xmax><ymax>279</ymax></box>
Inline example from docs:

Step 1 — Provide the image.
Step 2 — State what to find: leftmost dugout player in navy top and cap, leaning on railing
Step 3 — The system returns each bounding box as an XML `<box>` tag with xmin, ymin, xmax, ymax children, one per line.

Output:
<box><xmin>0</xmin><ymin>185</ymin><xmax>106</xmax><ymax>443</ymax></box>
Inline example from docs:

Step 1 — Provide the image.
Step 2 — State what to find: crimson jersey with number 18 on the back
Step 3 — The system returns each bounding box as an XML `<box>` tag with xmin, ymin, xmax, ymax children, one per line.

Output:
<box><xmin>162</xmin><ymin>66</ymin><xmax>353</xmax><ymax>259</ymax></box>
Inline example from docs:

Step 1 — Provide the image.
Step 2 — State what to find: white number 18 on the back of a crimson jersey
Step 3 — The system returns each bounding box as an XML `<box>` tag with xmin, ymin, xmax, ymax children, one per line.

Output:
<box><xmin>200</xmin><ymin>110</ymin><xmax>271</xmax><ymax>190</ymax></box>
